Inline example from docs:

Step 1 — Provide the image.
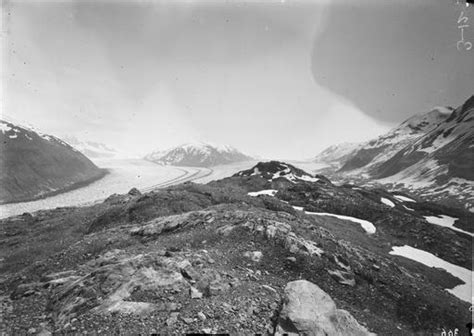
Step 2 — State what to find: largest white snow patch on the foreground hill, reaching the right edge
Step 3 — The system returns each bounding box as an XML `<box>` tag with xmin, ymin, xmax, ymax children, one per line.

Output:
<box><xmin>390</xmin><ymin>245</ymin><xmax>474</xmax><ymax>303</ymax></box>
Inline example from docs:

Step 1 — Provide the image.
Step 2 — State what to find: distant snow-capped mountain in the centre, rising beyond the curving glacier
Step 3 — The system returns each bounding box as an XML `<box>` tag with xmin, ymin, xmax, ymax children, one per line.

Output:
<box><xmin>145</xmin><ymin>142</ymin><xmax>252</xmax><ymax>167</ymax></box>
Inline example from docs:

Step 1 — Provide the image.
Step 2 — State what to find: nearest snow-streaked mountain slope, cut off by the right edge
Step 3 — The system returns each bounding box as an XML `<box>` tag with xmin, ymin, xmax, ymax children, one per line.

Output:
<box><xmin>371</xmin><ymin>96</ymin><xmax>474</xmax><ymax>210</ymax></box>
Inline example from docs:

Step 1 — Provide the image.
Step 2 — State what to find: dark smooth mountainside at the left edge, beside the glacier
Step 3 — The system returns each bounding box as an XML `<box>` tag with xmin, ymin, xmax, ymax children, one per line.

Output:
<box><xmin>0</xmin><ymin>120</ymin><xmax>105</xmax><ymax>203</ymax></box>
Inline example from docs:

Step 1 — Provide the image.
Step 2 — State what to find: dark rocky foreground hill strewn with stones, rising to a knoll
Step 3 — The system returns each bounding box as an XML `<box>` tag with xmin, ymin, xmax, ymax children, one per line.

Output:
<box><xmin>0</xmin><ymin>162</ymin><xmax>473</xmax><ymax>335</ymax></box>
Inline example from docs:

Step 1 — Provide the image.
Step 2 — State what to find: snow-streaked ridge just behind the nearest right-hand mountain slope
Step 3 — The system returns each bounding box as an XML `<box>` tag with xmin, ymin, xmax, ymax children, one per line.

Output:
<box><xmin>340</xmin><ymin>108</ymin><xmax>452</xmax><ymax>172</ymax></box>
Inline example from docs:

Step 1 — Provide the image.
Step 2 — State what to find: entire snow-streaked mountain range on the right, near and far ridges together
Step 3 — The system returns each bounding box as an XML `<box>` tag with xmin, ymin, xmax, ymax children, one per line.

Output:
<box><xmin>315</xmin><ymin>96</ymin><xmax>474</xmax><ymax>210</ymax></box>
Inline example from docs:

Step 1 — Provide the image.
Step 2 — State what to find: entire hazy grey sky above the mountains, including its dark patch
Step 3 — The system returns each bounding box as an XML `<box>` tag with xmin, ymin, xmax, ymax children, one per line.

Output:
<box><xmin>1</xmin><ymin>0</ymin><xmax>474</xmax><ymax>159</ymax></box>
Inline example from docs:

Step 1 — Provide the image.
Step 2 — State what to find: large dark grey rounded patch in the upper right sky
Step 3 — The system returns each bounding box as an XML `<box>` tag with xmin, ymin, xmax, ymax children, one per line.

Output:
<box><xmin>312</xmin><ymin>0</ymin><xmax>474</xmax><ymax>122</ymax></box>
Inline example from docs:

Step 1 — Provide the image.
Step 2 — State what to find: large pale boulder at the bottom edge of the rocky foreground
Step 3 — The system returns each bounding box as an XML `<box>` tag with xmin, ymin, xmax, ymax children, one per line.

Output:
<box><xmin>275</xmin><ymin>280</ymin><xmax>375</xmax><ymax>336</ymax></box>
